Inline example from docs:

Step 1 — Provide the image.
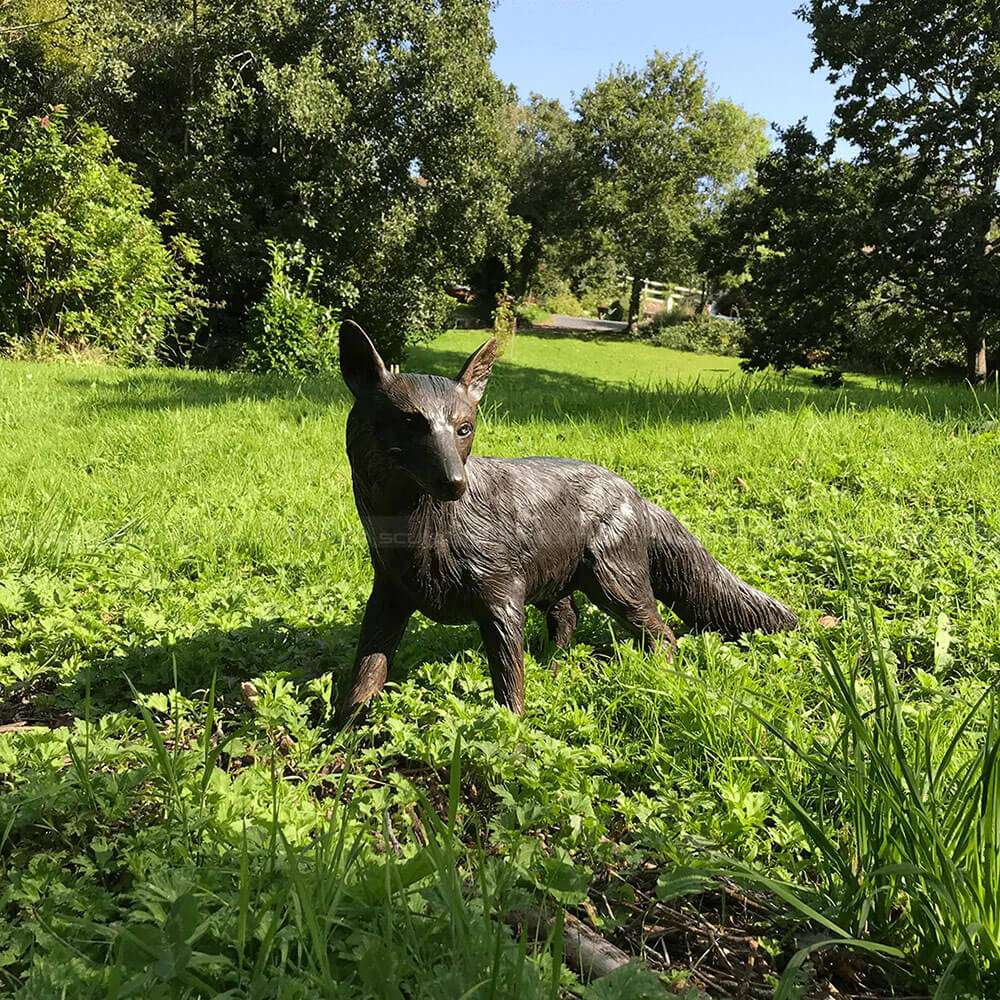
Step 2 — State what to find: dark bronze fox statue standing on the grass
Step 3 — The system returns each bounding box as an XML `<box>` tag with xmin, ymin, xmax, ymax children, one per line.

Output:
<box><xmin>340</xmin><ymin>322</ymin><xmax>798</xmax><ymax>718</ymax></box>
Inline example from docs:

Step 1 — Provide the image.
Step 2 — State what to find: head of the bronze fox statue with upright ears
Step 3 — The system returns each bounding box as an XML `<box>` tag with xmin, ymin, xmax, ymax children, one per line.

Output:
<box><xmin>340</xmin><ymin>320</ymin><xmax>497</xmax><ymax>500</ymax></box>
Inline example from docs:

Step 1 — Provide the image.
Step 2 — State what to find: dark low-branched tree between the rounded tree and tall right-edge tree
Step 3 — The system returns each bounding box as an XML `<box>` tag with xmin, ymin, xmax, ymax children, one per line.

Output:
<box><xmin>702</xmin><ymin>122</ymin><xmax>960</xmax><ymax>378</ymax></box>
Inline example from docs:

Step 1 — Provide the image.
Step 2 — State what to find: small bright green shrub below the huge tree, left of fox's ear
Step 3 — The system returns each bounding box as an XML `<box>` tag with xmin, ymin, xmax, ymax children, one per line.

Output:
<box><xmin>243</xmin><ymin>242</ymin><xmax>338</xmax><ymax>375</ymax></box>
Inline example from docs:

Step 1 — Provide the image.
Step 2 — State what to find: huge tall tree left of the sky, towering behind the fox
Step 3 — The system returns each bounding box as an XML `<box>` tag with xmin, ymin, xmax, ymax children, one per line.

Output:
<box><xmin>3</xmin><ymin>0</ymin><xmax>521</xmax><ymax>360</ymax></box>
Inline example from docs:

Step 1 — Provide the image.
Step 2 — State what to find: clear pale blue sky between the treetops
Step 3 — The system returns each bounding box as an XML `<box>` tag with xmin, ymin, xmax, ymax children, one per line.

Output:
<box><xmin>493</xmin><ymin>0</ymin><xmax>840</xmax><ymax>136</ymax></box>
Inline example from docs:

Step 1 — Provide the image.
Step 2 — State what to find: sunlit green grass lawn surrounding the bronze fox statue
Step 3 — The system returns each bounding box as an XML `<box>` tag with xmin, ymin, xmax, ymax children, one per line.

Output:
<box><xmin>0</xmin><ymin>331</ymin><xmax>1000</xmax><ymax>1000</ymax></box>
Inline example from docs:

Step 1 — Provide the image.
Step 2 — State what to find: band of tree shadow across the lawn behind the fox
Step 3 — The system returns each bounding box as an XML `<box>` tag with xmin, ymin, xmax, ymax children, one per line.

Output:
<box><xmin>64</xmin><ymin>344</ymin><xmax>1000</xmax><ymax>424</ymax></box>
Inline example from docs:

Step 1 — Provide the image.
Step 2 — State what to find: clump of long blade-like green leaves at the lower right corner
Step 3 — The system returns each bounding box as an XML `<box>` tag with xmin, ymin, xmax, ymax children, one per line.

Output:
<box><xmin>748</xmin><ymin>588</ymin><xmax>1000</xmax><ymax>995</ymax></box>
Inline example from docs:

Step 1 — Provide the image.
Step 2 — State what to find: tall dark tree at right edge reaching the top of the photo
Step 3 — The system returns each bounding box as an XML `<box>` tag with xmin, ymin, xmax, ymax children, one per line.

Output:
<box><xmin>799</xmin><ymin>0</ymin><xmax>1000</xmax><ymax>384</ymax></box>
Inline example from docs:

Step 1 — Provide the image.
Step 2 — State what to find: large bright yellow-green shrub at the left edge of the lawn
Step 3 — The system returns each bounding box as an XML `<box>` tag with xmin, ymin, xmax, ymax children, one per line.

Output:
<box><xmin>0</xmin><ymin>108</ymin><xmax>201</xmax><ymax>363</ymax></box>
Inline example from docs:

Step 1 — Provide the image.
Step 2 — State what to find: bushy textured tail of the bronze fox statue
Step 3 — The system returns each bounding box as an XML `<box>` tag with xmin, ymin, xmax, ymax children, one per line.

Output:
<box><xmin>649</xmin><ymin>504</ymin><xmax>799</xmax><ymax>639</ymax></box>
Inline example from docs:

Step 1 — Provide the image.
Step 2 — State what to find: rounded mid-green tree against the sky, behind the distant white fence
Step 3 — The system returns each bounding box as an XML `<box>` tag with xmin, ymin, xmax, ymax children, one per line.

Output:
<box><xmin>577</xmin><ymin>53</ymin><xmax>767</xmax><ymax>332</ymax></box>
